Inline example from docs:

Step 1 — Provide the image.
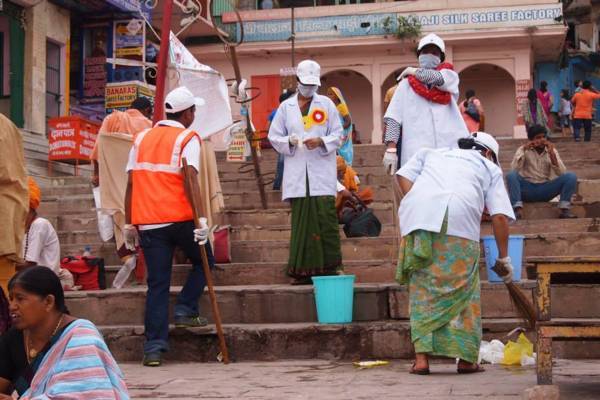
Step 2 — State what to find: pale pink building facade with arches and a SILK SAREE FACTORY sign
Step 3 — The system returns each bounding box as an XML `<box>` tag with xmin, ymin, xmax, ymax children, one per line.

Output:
<box><xmin>190</xmin><ymin>0</ymin><xmax>567</xmax><ymax>143</ymax></box>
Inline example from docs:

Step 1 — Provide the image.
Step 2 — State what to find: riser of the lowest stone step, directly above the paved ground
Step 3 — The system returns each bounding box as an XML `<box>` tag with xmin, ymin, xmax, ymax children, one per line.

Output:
<box><xmin>99</xmin><ymin>318</ymin><xmax>600</xmax><ymax>366</ymax></box>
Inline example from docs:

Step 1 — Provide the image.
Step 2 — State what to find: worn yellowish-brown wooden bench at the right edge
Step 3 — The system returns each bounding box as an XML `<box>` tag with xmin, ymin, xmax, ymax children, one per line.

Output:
<box><xmin>527</xmin><ymin>257</ymin><xmax>600</xmax><ymax>385</ymax></box>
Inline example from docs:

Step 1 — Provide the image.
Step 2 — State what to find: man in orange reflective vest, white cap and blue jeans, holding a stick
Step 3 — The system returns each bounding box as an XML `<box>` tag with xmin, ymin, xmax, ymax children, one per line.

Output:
<box><xmin>124</xmin><ymin>87</ymin><xmax>214</xmax><ymax>367</ymax></box>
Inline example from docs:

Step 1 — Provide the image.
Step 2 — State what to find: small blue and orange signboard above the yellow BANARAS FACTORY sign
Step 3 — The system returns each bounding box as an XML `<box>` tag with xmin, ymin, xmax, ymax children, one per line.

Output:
<box><xmin>113</xmin><ymin>18</ymin><xmax>146</xmax><ymax>61</ymax></box>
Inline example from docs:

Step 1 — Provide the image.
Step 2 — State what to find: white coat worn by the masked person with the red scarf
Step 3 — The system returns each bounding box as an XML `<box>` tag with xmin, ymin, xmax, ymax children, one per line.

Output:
<box><xmin>385</xmin><ymin>69</ymin><xmax>469</xmax><ymax>165</ymax></box>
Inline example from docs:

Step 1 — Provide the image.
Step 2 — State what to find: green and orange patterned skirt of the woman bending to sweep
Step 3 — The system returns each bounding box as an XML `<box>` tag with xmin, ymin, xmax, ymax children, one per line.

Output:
<box><xmin>396</xmin><ymin>223</ymin><xmax>482</xmax><ymax>363</ymax></box>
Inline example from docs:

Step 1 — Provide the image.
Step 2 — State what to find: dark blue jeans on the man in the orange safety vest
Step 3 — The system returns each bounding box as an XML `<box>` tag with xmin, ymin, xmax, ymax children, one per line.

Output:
<box><xmin>140</xmin><ymin>221</ymin><xmax>215</xmax><ymax>353</ymax></box>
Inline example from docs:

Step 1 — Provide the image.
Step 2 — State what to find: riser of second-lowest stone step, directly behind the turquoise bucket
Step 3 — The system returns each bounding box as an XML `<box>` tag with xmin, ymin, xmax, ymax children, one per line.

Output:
<box><xmin>67</xmin><ymin>281</ymin><xmax>600</xmax><ymax>325</ymax></box>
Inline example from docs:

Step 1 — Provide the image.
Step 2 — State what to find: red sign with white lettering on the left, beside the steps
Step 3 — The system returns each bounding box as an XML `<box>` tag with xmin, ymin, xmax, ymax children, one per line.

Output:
<box><xmin>48</xmin><ymin>117</ymin><xmax>100</xmax><ymax>161</ymax></box>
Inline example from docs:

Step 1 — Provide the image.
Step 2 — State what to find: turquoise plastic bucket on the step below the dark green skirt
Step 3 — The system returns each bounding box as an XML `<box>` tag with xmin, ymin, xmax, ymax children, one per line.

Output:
<box><xmin>312</xmin><ymin>275</ymin><xmax>355</xmax><ymax>324</ymax></box>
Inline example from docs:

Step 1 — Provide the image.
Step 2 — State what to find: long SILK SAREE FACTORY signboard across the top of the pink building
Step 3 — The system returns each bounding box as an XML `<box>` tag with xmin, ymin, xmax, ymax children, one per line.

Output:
<box><xmin>234</xmin><ymin>3</ymin><xmax>562</xmax><ymax>42</ymax></box>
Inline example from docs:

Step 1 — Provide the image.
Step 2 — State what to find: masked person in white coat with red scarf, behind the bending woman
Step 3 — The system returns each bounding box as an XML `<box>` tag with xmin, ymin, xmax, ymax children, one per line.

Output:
<box><xmin>383</xmin><ymin>33</ymin><xmax>469</xmax><ymax>175</ymax></box>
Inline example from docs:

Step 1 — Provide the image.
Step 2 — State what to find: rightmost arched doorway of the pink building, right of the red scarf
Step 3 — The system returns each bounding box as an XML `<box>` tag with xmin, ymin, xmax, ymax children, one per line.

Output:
<box><xmin>460</xmin><ymin>64</ymin><xmax>517</xmax><ymax>136</ymax></box>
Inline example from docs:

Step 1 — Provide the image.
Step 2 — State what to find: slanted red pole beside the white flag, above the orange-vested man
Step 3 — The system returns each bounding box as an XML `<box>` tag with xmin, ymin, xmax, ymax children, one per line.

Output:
<box><xmin>153</xmin><ymin>0</ymin><xmax>173</xmax><ymax>123</ymax></box>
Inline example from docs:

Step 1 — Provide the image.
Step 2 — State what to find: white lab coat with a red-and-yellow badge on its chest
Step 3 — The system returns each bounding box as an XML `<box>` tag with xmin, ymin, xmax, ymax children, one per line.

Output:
<box><xmin>269</xmin><ymin>94</ymin><xmax>342</xmax><ymax>200</ymax></box>
